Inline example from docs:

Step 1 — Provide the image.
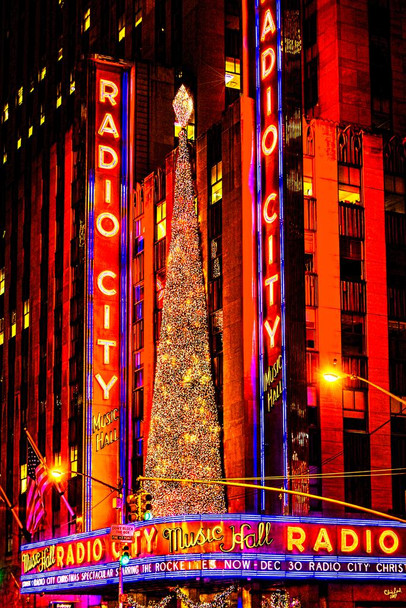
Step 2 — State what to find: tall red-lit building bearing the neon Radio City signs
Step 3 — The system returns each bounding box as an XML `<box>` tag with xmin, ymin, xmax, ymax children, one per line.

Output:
<box><xmin>0</xmin><ymin>0</ymin><xmax>406</xmax><ymax>608</ymax></box>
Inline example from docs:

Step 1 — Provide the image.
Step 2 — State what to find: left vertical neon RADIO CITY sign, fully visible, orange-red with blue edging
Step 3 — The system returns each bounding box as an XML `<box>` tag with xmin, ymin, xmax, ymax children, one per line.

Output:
<box><xmin>84</xmin><ymin>61</ymin><xmax>128</xmax><ymax>530</ymax></box>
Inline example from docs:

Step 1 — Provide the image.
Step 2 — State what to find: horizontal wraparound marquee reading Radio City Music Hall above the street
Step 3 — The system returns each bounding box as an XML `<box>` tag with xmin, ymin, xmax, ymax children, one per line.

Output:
<box><xmin>21</xmin><ymin>514</ymin><xmax>406</xmax><ymax>593</ymax></box>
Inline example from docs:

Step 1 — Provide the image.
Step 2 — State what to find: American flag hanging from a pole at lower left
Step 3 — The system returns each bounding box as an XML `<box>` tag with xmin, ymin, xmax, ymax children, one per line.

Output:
<box><xmin>26</xmin><ymin>445</ymin><xmax>51</xmax><ymax>534</ymax></box>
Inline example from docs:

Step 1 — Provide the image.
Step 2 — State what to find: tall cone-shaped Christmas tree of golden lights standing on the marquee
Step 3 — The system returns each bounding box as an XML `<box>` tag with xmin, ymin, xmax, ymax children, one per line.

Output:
<box><xmin>145</xmin><ymin>85</ymin><xmax>225</xmax><ymax>517</ymax></box>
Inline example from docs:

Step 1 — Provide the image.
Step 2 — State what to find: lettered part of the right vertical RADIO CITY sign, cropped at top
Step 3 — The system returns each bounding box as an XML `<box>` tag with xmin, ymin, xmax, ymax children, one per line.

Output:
<box><xmin>257</xmin><ymin>0</ymin><xmax>283</xmax><ymax>412</ymax></box>
